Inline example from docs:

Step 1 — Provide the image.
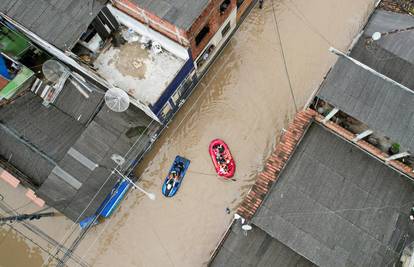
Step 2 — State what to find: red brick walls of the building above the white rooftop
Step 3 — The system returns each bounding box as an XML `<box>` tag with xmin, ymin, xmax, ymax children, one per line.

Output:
<box><xmin>114</xmin><ymin>0</ymin><xmax>236</xmax><ymax>59</ymax></box>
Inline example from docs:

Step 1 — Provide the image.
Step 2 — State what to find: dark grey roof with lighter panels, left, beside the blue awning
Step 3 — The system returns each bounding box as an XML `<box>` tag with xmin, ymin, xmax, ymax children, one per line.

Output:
<box><xmin>0</xmin><ymin>83</ymin><xmax>150</xmax><ymax>220</ymax></box>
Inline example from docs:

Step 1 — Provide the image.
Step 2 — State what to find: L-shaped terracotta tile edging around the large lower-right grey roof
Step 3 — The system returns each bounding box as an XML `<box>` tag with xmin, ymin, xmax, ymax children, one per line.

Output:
<box><xmin>237</xmin><ymin>109</ymin><xmax>414</xmax><ymax>220</ymax></box>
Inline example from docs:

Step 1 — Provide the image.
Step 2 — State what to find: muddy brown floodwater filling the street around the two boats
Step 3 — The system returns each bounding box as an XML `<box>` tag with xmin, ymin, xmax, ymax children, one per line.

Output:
<box><xmin>76</xmin><ymin>0</ymin><xmax>374</xmax><ymax>266</ymax></box>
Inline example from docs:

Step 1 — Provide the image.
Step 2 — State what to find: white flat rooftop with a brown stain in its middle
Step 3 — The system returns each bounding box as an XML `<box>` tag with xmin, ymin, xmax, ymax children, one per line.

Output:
<box><xmin>94</xmin><ymin>28</ymin><xmax>185</xmax><ymax>105</ymax></box>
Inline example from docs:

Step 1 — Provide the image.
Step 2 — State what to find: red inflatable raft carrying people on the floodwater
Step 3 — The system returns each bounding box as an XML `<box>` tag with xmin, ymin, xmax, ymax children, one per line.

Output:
<box><xmin>209</xmin><ymin>139</ymin><xmax>236</xmax><ymax>179</ymax></box>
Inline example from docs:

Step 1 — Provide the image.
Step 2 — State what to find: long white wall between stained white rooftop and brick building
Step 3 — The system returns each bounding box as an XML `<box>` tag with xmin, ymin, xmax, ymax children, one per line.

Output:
<box><xmin>107</xmin><ymin>4</ymin><xmax>189</xmax><ymax>61</ymax></box>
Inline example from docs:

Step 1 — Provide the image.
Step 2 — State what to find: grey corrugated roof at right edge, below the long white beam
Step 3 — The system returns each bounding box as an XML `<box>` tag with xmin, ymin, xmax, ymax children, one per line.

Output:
<box><xmin>318</xmin><ymin>58</ymin><xmax>414</xmax><ymax>151</ymax></box>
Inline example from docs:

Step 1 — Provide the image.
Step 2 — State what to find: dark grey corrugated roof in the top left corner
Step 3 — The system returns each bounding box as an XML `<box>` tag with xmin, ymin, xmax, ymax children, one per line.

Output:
<box><xmin>0</xmin><ymin>0</ymin><xmax>107</xmax><ymax>50</ymax></box>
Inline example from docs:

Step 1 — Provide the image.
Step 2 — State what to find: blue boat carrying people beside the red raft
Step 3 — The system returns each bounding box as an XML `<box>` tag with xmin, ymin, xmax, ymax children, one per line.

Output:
<box><xmin>162</xmin><ymin>156</ymin><xmax>190</xmax><ymax>197</ymax></box>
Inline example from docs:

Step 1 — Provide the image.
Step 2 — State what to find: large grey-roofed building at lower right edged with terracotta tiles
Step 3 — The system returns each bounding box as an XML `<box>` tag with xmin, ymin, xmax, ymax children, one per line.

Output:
<box><xmin>210</xmin><ymin>110</ymin><xmax>414</xmax><ymax>266</ymax></box>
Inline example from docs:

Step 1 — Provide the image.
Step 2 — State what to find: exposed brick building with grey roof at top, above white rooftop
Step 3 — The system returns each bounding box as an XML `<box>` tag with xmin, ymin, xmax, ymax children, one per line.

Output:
<box><xmin>114</xmin><ymin>0</ymin><xmax>244</xmax><ymax>63</ymax></box>
